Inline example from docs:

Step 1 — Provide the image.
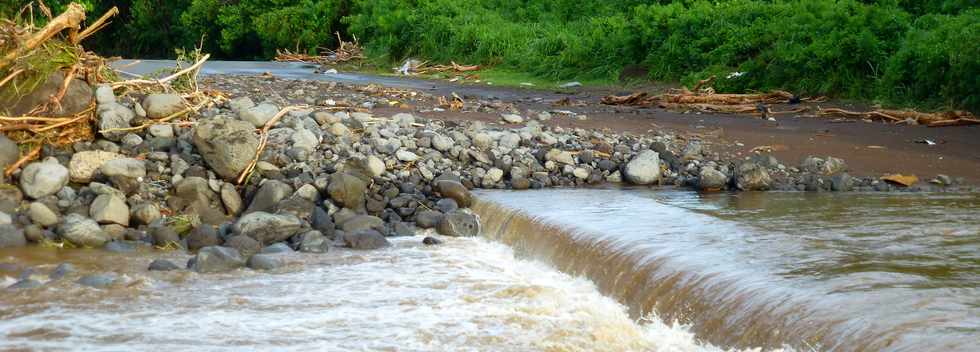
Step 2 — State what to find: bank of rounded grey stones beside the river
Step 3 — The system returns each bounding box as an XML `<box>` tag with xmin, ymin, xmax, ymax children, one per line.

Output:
<box><xmin>0</xmin><ymin>76</ymin><xmax>972</xmax><ymax>287</ymax></box>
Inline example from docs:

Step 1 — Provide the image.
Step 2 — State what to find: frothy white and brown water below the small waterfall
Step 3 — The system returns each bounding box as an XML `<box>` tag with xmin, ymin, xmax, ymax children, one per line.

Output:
<box><xmin>0</xmin><ymin>232</ymin><xmax>736</xmax><ymax>352</ymax></box>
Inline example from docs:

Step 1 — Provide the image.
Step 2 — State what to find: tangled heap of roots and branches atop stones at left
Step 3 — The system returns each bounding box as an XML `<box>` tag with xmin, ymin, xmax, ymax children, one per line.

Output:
<box><xmin>0</xmin><ymin>3</ymin><xmax>221</xmax><ymax>175</ymax></box>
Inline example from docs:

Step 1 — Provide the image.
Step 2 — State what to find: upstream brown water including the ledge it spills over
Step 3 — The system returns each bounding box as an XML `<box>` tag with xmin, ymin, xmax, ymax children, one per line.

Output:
<box><xmin>476</xmin><ymin>189</ymin><xmax>980</xmax><ymax>351</ymax></box>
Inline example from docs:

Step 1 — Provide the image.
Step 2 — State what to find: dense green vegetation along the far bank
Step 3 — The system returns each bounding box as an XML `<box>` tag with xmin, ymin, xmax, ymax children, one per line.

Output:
<box><xmin>0</xmin><ymin>0</ymin><xmax>980</xmax><ymax>111</ymax></box>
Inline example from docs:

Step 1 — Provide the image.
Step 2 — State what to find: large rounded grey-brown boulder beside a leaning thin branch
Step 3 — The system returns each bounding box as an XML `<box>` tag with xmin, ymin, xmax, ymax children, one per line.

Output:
<box><xmin>193</xmin><ymin>119</ymin><xmax>259</xmax><ymax>181</ymax></box>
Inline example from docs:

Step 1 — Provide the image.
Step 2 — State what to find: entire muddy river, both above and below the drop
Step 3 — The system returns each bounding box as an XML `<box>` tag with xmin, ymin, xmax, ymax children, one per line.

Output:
<box><xmin>0</xmin><ymin>189</ymin><xmax>980</xmax><ymax>351</ymax></box>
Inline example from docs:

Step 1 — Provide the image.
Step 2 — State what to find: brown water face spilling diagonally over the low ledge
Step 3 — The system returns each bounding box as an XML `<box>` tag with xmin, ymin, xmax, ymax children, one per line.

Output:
<box><xmin>473</xmin><ymin>199</ymin><xmax>900</xmax><ymax>351</ymax></box>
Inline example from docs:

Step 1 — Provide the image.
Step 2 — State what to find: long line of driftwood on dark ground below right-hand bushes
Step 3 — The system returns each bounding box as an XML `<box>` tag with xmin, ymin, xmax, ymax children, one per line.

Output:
<box><xmin>602</xmin><ymin>76</ymin><xmax>980</xmax><ymax>127</ymax></box>
